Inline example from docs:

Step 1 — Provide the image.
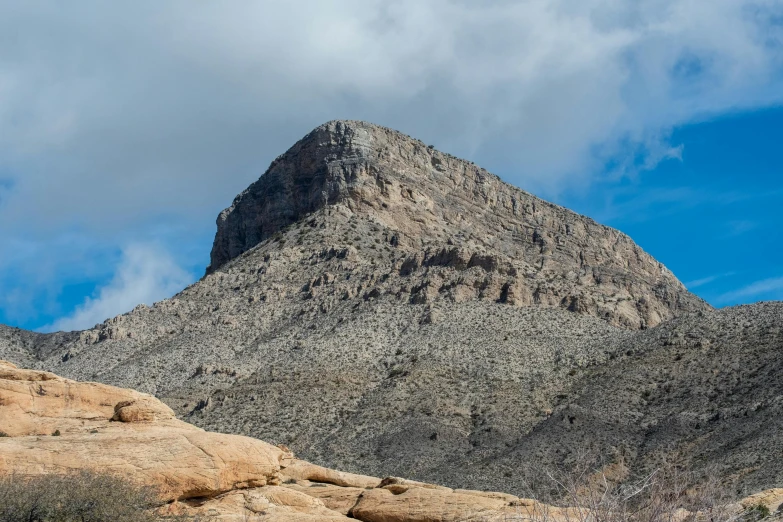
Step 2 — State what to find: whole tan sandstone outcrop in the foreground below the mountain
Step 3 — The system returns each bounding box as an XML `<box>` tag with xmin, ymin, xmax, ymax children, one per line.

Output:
<box><xmin>0</xmin><ymin>361</ymin><xmax>588</xmax><ymax>522</ymax></box>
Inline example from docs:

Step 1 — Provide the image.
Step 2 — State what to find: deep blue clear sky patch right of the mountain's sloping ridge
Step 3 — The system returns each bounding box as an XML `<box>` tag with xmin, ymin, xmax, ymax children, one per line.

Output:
<box><xmin>558</xmin><ymin>109</ymin><xmax>783</xmax><ymax>306</ymax></box>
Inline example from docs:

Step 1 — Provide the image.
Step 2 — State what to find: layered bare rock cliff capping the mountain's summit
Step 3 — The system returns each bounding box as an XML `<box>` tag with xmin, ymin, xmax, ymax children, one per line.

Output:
<box><xmin>208</xmin><ymin>121</ymin><xmax>707</xmax><ymax>328</ymax></box>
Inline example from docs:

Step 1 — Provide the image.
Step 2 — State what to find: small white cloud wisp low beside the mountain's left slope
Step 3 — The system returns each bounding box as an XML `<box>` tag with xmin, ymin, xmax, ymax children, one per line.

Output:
<box><xmin>41</xmin><ymin>244</ymin><xmax>193</xmax><ymax>331</ymax></box>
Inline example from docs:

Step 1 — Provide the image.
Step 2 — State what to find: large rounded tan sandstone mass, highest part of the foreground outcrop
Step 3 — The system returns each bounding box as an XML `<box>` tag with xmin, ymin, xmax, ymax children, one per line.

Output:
<box><xmin>0</xmin><ymin>361</ymin><xmax>290</xmax><ymax>500</ymax></box>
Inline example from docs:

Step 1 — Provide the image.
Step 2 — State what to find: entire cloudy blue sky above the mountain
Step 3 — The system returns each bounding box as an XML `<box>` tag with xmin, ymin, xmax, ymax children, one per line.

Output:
<box><xmin>0</xmin><ymin>0</ymin><xmax>783</xmax><ymax>331</ymax></box>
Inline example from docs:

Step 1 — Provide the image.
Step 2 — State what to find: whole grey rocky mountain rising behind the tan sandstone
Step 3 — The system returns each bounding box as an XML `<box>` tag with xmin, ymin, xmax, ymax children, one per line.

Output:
<box><xmin>0</xmin><ymin>121</ymin><xmax>783</xmax><ymax>493</ymax></box>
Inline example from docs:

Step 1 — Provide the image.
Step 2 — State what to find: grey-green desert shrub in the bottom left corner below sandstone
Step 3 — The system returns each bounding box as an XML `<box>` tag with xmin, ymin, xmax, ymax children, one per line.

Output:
<box><xmin>0</xmin><ymin>471</ymin><xmax>164</xmax><ymax>522</ymax></box>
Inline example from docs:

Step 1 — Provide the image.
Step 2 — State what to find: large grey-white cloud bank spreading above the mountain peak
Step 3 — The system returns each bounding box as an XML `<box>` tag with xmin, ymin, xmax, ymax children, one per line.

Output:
<box><xmin>0</xmin><ymin>0</ymin><xmax>783</xmax><ymax>324</ymax></box>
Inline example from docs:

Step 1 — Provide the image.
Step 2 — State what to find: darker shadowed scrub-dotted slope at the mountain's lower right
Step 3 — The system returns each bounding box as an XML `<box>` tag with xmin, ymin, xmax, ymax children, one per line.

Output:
<box><xmin>503</xmin><ymin>302</ymin><xmax>783</xmax><ymax>494</ymax></box>
